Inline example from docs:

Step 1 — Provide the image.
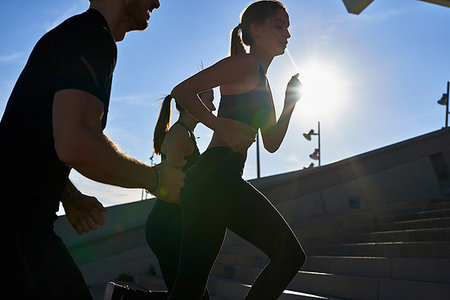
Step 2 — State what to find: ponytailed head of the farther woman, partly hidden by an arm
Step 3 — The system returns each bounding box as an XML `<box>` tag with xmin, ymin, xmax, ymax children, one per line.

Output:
<box><xmin>153</xmin><ymin>90</ymin><xmax>216</xmax><ymax>155</ymax></box>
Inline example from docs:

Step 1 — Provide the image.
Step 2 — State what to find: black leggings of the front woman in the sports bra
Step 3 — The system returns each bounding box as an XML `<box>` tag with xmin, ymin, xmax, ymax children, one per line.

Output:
<box><xmin>168</xmin><ymin>147</ymin><xmax>305</xmax><ymax>300</ymax></box>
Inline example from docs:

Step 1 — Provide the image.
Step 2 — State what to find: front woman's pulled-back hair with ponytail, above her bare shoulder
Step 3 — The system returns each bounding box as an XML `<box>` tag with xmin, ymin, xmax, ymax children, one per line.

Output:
<box><xmin>230</xmin><ymin>0</ymin><xmax>286</xmax><ymax>55</ymax></box>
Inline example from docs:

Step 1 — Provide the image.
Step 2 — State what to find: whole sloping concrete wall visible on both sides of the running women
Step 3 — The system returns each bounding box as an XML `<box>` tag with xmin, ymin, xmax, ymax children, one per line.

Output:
<box><xmin>55</xmin><ymin>129</ymin><xmax>450</xmax><ymax>285</ymax></box>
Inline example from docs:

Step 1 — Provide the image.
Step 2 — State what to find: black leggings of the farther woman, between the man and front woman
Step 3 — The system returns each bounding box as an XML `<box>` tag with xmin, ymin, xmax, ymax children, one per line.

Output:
<box><xmin>145</xmin><ymin>199</ymin><xmax>210</xmax><ymax>300</ymax></box>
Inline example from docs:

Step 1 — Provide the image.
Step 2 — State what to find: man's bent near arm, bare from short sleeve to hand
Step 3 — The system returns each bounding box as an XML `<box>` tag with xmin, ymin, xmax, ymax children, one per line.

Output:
<box><xmin>53</xmin><ymin>89</ymin><xmax>184</xmax><ymax>202</ymax></box>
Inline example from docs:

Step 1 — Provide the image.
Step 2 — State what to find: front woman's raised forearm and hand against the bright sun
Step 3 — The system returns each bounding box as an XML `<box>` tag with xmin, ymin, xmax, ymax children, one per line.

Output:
<box><xmin>261</xmin><ymin>74</ymin><xmax>301</xmax><ymax>153</ymax></box>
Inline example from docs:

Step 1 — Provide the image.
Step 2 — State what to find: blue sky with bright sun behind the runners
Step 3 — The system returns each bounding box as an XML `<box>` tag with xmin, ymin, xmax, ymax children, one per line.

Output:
<box><xmin>0</xmin><ymin>0</ymin><xmax>450</xmax><ymax>211</ymax></box>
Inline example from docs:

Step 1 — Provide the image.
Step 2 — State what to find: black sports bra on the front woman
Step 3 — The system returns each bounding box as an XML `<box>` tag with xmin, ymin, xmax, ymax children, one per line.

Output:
<box><xmin>217</xmin><ymin>65</ymin><xmax>271</xmax><ymax>129</ymax></box>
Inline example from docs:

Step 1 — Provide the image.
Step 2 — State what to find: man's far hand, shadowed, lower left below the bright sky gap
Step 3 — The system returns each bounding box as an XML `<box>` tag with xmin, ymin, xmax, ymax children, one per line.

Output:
<box><xmin>63</xmin><ymin>191</ymin><xmax>106</xmax><ymax>235</ymax></box>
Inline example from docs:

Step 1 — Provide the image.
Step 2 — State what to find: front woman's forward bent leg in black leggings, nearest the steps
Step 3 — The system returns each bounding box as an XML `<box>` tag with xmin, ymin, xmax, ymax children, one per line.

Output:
<box><xmin>226</xmin><ymin>179</ymin><xmax>305</xmax><ymax>299</ymax></box>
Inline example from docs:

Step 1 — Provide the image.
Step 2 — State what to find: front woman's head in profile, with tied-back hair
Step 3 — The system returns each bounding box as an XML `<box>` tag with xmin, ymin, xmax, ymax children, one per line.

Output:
<box><xmin>231</xmin><ymin>0</ymin><xmax>290</xmax><ymax>56</ymax></box>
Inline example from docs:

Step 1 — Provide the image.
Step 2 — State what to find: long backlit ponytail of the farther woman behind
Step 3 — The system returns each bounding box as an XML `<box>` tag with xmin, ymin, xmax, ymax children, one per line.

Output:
<box><xmin>153</xmin><ymin>95</ymin><xmax>185</xmax><ymax>155</ymax></box>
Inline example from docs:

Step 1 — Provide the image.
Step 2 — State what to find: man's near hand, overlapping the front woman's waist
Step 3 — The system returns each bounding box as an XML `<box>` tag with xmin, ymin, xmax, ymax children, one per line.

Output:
<box><xmin>152</xmin><ymin>160</ymin><xmax>186</xmax><ymax>203</ymax></box>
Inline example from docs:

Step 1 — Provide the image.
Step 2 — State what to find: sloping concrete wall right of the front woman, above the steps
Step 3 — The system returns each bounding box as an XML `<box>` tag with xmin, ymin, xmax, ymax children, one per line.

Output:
<box><xmin>254</xmin><ymin>129</ymin><xmax>450</xmax><ymax>221</ymax></box>
